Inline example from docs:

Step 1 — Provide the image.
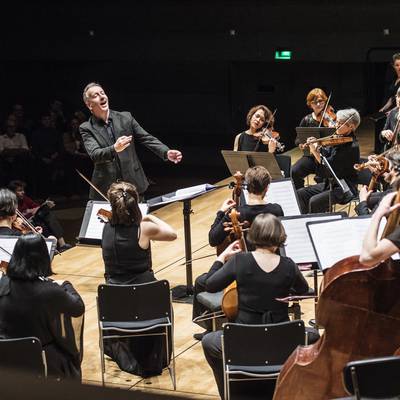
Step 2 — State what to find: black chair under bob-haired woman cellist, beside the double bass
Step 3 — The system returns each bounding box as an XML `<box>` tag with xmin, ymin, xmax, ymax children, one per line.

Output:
<box><xmin>221</xmin><ymin>320</ymin><xmax>306</xmax><ymax>399</ymax></box>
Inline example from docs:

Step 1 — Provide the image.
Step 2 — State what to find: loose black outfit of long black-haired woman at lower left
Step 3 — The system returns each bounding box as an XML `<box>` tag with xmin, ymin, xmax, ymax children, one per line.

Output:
<box><xmin>0</xmin><ymin>276</ymin><xmax>85</xmax><ymax>379</ymax></box>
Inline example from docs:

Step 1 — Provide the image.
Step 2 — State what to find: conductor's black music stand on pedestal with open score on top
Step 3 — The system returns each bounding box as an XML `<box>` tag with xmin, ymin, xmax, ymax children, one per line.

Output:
<box><xmin>147</xmin><ymin>184</ymin><xmax>219</xmax><ymax>303</ymax></box>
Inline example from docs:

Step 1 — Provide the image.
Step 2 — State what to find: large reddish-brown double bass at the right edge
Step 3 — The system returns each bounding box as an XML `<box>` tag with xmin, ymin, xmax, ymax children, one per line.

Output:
<box><xmin>274</xmin><ymin>190</ymin><xmax>400</xmax><ymax>400</ymax></box>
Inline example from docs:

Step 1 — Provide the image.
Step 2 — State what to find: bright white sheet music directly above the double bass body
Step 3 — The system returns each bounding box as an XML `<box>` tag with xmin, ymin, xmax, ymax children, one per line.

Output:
<box><xmin>308</xmin><ymin>217</ymin><xmax>386</xmax><ymax>270</ymax></box>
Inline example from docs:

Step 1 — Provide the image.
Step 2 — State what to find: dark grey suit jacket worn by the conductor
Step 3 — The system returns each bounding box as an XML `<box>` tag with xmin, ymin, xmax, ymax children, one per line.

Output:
<box><xmin>79</xmin><ymin>110</ymin><xmax>169</xmax><ymax>199</ymax></box>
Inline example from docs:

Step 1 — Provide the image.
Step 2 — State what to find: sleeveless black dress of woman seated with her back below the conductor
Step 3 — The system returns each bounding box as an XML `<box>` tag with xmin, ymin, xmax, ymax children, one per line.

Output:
<box><xmin>102</xmin><ymin>223</ymin><xmax>172</xmax><ymax>377</ymax></box>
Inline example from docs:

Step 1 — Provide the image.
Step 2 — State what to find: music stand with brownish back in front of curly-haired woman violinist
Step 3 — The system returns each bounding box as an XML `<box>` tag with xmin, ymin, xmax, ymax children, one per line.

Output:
<box><xmin>221</xmin><ymin>150</ymin><xmax>282</xmax><ymax>180</ymax></box>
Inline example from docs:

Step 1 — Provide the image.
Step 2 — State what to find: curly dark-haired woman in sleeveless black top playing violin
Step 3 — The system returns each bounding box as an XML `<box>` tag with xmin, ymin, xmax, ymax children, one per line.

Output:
<box><xmin>233</xmin><ymin>105</ymin><xmax>278</xmax><ymax>153</ymax></box>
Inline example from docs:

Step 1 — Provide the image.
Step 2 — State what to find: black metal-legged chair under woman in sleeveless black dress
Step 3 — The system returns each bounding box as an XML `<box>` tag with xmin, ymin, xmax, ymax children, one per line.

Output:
<box><xmin>97</xmin><ymin>280</ymin><xmax>176</xmax><ymax>390</ymax></box>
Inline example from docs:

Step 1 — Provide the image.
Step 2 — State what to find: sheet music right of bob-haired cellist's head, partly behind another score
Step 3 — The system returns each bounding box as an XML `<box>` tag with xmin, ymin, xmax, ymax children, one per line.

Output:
<box><xmin>281</xmin><ymin>214</ymin><xmax>342</xmax><ymax>264</ymax></box>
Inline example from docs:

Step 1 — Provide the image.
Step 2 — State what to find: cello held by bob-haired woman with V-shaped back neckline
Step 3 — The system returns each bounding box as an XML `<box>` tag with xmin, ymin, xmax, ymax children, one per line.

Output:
<box><xmin>222</xmin><ymin>209</ymin><xmax>248</xmax><ymax>321</ymax></box>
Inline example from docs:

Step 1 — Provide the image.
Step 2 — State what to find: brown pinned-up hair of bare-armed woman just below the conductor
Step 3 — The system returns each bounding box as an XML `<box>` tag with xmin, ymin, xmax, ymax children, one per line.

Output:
<box><xmin>107</xmin><ymin>182</ymin><xmax>142</xmax><ymax>225</ymax></box>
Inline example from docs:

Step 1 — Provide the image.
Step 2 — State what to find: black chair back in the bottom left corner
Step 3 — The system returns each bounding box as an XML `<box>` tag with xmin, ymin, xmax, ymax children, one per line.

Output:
<box><xmin>0</xmin><ymin>337</ymin><xmax>47</xmax><ymax>378</ymax></box>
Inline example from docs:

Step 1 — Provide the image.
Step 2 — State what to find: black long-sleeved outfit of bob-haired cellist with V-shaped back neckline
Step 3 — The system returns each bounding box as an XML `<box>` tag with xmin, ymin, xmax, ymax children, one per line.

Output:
<box><xmin>202</xmin><ymin>253</ymin><xmax>308</xmax><ymax>399</ymax></box>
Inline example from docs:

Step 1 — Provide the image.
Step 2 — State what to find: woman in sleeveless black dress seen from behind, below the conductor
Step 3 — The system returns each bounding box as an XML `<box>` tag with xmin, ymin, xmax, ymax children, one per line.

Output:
<box><xmin>101</xmin><ymin>182</ymin><xmax>176</xmax><ymax>377</ymax></box>
